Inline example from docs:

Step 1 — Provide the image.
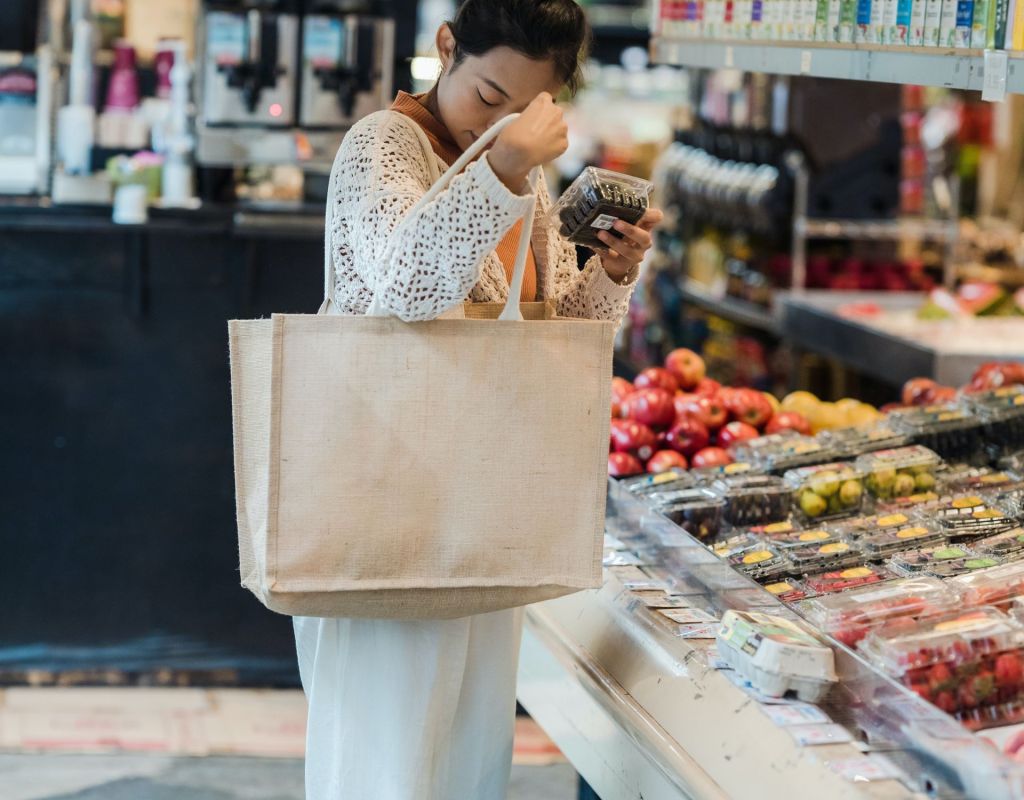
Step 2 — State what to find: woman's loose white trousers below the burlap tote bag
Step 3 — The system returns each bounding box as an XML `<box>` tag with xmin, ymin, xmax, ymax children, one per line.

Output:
<box><xmin>294</xmin><ymin>609</ymin><xmax>522</xmax><ymax>800</ymax></box>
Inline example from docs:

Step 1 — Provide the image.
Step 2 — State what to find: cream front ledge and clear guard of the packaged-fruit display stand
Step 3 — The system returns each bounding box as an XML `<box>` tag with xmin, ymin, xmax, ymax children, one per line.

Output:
<box><xmin>518</xmin><ymin>481</ymin><xmax>1024</xmax><ymax>800</ymax></box>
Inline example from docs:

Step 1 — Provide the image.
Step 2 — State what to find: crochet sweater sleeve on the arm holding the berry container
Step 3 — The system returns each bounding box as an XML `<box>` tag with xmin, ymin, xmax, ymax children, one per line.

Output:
<box><xmin>538</xmin><ymin>181</ymin><xmax>639</xmax><ymax>323</ymax></box>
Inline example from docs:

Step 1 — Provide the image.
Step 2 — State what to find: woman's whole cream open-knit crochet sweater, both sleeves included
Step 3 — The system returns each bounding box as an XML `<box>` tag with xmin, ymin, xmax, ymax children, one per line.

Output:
<box><xmin>326</xmin><ymin>111</ymin><xmax>637</xmax><ymax>322</ymax></box>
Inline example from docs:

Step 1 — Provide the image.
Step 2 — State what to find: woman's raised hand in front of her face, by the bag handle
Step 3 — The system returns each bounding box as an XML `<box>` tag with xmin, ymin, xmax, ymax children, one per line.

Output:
<box><xmin>487</xmin><ymin>92</ymin><xmax>569</xmax><ymax>193</ymax></box>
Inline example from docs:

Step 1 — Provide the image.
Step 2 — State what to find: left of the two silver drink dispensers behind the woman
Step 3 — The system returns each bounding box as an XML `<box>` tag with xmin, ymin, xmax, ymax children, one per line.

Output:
<box><xmin>196</xmin><ymin>0</ymin><xmax>300</xmax><ymax>166</ymax></box>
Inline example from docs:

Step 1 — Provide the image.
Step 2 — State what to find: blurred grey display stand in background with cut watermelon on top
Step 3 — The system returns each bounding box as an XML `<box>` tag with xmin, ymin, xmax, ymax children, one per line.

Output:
<box><xmin>778</xmin><ymin>291</ymin><xmax>1024</xmax><ymax>385</ymax></box>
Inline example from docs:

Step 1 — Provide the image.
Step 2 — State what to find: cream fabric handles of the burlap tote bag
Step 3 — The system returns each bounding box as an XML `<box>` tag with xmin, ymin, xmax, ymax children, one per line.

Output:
<box><xmin>317</xmin><ymin>114</ymin><xmax>541</xmax><ymax>321</ymax></box>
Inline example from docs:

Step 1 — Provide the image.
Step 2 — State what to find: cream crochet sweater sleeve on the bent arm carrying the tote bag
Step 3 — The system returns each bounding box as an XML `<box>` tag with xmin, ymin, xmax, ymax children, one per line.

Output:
<box><xmin>331</xmin><ymin>112</ymin><xmax>529</xmax><ymax>321</ymax></box>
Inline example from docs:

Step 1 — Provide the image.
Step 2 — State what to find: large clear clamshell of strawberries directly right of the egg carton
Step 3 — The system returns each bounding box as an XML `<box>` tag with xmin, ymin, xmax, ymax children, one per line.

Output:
<box><xmin>861</xmin><ymin>608</ymin><xmax>1024</xmax><ymax>726</ymax></box>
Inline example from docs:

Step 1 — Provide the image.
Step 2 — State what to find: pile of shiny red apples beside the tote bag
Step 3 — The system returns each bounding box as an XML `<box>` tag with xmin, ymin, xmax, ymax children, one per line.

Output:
<box><xmin>608</xmin><ymin>348</ymin><xmax>811</xmax><ymax>477</ymax></box>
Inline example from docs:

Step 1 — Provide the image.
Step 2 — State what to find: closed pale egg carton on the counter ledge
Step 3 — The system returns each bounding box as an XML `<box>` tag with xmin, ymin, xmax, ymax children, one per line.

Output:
<box><xmin>717</xmin><ymin>609</ymin><xmax>837</xmax><ymax>703</ymax></box>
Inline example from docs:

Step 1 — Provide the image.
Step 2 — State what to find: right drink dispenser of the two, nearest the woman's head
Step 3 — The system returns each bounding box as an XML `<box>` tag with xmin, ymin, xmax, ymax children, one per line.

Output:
<box><xmin>299</xmin><ymin>9</ymin><xmax>394</xmax><ymax>130</ymax></box>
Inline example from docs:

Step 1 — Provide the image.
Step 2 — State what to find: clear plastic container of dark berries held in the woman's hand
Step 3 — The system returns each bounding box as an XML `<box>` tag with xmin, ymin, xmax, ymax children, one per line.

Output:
<box><xmin>550</xmin><ymin>167</ymin><xmax>654</xmax><ymax>248</ymax></box>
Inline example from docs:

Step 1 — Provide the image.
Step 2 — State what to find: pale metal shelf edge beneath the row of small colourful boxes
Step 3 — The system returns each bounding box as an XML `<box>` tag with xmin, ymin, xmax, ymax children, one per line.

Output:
<box><xmin>651</xmin><ymin>37</ymin><xmax>1024</xmax><ymax>93</ymax></box>
